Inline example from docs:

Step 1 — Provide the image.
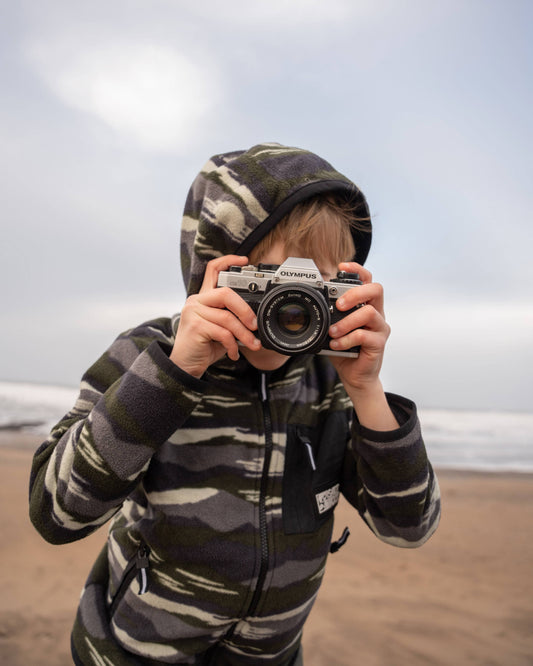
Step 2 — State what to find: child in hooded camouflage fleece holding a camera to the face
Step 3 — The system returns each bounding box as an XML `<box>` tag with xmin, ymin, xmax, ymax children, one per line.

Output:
<box><xmin>30</xmin><ymin>144</ymin><xmax>440</xmax><ymax>666</ymax></box>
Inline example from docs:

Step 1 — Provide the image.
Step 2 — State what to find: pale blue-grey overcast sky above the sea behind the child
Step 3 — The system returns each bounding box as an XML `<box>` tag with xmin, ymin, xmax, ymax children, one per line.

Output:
<box><xmin>0</xmin><ymin>0</ymin><xmax>533</xmax><ymax>411</ymax></box>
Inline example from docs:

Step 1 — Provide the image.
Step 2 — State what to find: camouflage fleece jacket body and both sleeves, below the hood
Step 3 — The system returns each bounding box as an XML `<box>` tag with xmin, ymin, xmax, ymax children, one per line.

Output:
<box><xmin>30</xmin><ymin>143</ymin><xmax>440</xmax><ymax>666</ymax></box>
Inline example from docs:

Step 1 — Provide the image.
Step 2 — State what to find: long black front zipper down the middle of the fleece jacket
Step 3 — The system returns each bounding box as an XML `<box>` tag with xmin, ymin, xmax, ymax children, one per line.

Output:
<box><xmin>243</xmin><ymin>373</ymin><xmax>273</xmax><ymax>615</ymax></box>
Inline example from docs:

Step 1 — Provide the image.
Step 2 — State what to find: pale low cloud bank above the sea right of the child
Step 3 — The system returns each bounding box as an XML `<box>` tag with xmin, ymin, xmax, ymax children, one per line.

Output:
<box><xmin>384</xmin><ymin>299</ymin><xmax>533</xmax><ymax>411</ymax></box>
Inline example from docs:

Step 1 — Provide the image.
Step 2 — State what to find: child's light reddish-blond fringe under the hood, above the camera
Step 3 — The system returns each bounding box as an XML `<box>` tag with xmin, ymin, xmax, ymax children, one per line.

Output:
<box><xmin>248</xmin><ymin>194</ymin><xmax>368</xmax><ymax>266</ymax></box>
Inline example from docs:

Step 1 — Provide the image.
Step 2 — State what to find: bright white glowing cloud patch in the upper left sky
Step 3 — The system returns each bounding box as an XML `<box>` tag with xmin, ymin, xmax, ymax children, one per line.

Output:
<box><xmin>26</xmin><ymin>38</ymin><xmax>220</xmax><ymax>151</ymax></box>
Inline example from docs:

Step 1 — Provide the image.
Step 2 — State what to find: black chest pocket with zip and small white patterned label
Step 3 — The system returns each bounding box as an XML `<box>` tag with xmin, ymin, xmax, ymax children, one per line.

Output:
<box><xmin>282</xmin><ymin>412</ymin><xmax>349</xmax><ymax>534</ymax></box>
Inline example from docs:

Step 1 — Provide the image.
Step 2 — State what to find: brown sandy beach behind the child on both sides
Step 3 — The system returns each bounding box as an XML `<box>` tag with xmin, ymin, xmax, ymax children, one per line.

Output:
<box><xmin>0</xmin><ymin>430</ymin><xmax>533</xmax><ymax>666</ymax></box>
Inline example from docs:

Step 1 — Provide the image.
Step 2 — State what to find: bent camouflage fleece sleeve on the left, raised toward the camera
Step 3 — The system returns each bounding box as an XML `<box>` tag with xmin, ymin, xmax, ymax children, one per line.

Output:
<box><xmin>30</xmin><ymin>322</ymin><xmax>204</xmax><ymax>543</ymax></box>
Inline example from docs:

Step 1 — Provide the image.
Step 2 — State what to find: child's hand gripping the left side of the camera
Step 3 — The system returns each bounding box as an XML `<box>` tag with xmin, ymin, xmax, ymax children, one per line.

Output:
<box><xmin>170</xmin><ymin>255</ymin><xmax>261</xmax><ymax>377</ymax></box>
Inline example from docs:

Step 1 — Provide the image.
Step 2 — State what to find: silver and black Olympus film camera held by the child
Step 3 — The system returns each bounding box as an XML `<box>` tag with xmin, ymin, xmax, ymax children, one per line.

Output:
<box><xmin>217</xmin><ymin>257</ymin><xmax>363</xmax><ymax>358</ymax></box>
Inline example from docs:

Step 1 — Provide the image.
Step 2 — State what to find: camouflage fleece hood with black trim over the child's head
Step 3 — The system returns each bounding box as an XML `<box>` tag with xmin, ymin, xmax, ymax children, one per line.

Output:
<box><xmin>181</xmin><ymin>143</ymin><xmax>372</xmax><ymax>294</ymax></box>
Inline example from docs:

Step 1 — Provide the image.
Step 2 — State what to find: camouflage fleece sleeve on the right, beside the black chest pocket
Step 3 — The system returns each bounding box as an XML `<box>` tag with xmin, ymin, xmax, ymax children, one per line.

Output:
<box><xmin>343</xmin><ymin>394</ymin><xmax>440</xmax><ymax>548</ymax></box>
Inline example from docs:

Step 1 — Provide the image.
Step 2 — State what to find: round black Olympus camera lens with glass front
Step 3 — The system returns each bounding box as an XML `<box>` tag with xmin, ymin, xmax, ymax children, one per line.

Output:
<box><xmin>257</xmin><ymin>284</ymin><xmax>330</xmax><ymax>356</ymax></box>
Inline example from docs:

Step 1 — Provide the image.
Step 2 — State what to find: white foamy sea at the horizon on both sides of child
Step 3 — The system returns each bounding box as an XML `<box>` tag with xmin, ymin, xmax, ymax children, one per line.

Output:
<box><xmin>0</xmin><ymin>382</ymin><xmax>533</xmax><ymax>472</ymax></box>
